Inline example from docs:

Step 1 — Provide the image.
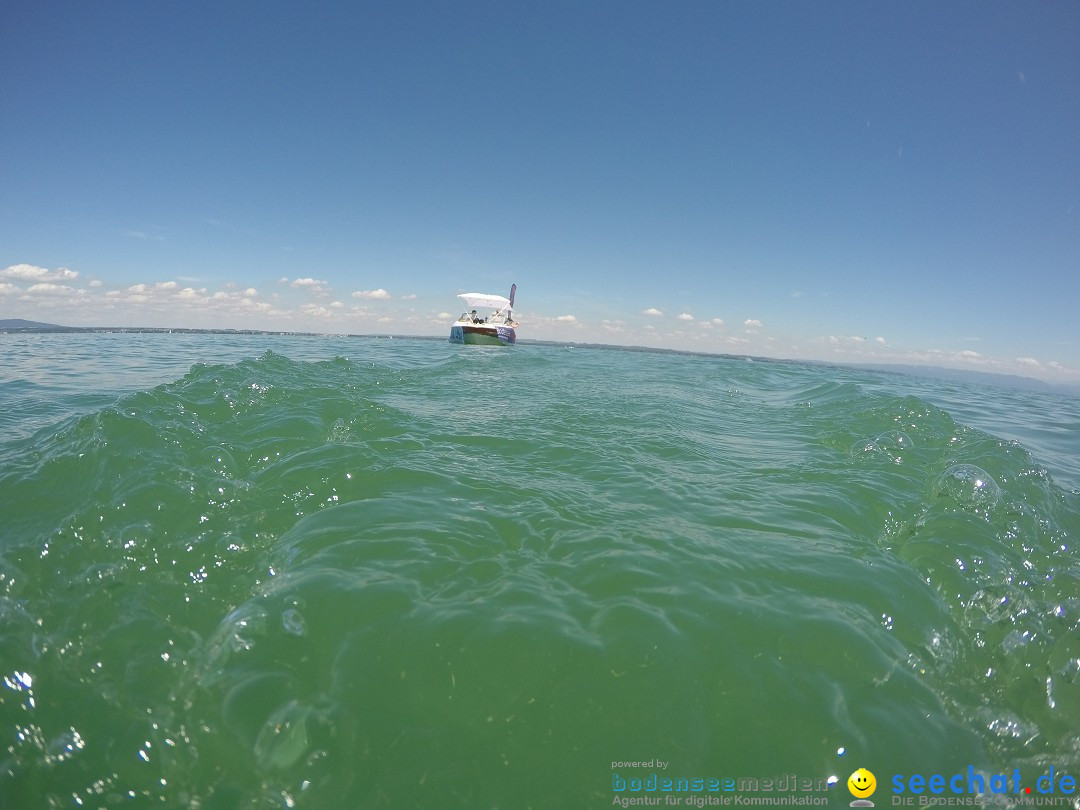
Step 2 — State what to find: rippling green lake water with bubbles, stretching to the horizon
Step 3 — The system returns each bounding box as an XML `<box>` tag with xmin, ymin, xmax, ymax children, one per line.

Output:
<box><xmin>0</xmin><ymin>336</ymin><xmax>1080</xmax><ymax>808</ymax></box>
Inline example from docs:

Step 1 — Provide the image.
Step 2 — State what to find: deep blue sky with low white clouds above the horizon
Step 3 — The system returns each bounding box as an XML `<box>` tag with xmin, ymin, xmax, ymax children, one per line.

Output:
<box><xmin>6</xmin><ymin>0</ymin><xmax>1080</xmax><ymax>382</ymax></box>
